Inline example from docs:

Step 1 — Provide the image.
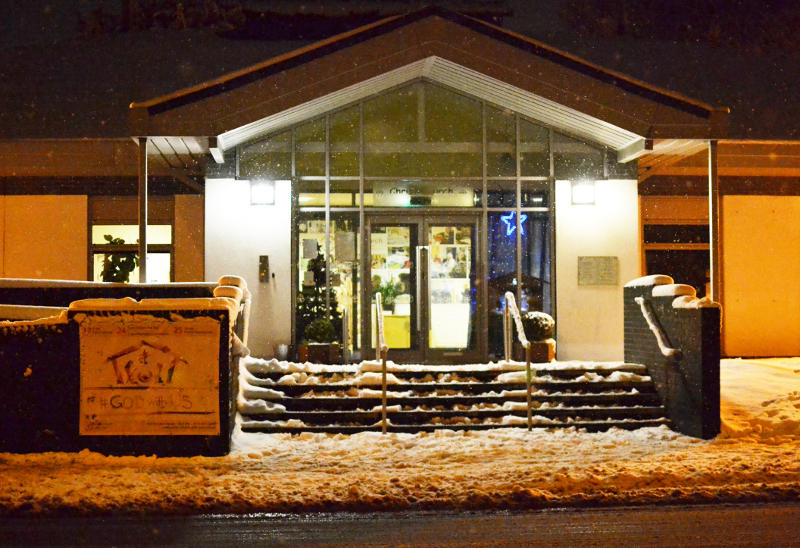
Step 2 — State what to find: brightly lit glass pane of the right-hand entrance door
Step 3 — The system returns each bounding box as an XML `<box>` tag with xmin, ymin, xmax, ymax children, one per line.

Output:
<box><xmin>428</xmin><ymin>225</ymin><xmax>475</xmax><ymax>350</ymax></box>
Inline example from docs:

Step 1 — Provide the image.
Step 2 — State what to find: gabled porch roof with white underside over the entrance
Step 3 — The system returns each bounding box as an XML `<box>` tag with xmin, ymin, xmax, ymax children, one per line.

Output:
<box><xmin>131</xmin><ymin>8</ymin><xmax>727</xmax><ymax>151</ymax></box>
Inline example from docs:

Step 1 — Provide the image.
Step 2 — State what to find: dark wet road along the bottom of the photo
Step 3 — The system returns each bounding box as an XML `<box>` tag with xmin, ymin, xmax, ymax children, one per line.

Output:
<box><xmin>0</xmin><ymin>503</ymin><xmax>800</xmax><ymax>548</ymax></box>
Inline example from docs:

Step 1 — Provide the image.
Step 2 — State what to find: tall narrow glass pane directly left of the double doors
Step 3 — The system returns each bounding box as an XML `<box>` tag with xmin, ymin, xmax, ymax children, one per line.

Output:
<box><xmin>331</xmin><ymin>213</ymin><xmax>361</xmax><ymax>351</ymax></box>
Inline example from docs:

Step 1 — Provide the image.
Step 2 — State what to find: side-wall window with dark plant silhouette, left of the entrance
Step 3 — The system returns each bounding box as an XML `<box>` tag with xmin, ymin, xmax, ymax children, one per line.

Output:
<box><xmin>89</xmin><ymin>196</ymin><xmax>174</xmax><ymax>283</ymax></box>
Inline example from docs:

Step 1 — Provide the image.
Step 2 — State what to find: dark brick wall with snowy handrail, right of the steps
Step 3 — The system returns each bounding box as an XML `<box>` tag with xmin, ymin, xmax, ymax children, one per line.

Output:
<box><xmin>624</xmin><ymin>286</ymin><xmax>720</xmax><ymax>439</ymax></box>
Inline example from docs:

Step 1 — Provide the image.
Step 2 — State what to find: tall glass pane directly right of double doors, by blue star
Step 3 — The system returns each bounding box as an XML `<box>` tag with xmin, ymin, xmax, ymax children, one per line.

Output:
<box><xmin>487</xmin><ymin>210</ymin><xmax>517</xmax><ymax>359</ymax></box>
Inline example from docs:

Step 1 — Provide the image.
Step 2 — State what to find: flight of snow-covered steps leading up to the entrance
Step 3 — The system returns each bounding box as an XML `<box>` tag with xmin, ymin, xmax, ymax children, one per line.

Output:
<box><xmin>239</xmin><ymin>358</ymin><xmax>669</xmax><ymax>433</ymax></box>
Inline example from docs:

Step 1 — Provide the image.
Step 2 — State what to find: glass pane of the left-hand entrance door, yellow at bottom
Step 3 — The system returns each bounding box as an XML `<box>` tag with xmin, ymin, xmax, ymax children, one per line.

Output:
<box><xmin>370</xmin><ymin>225</ymin><xmax>416</xmax><ymax>349</ymax></box>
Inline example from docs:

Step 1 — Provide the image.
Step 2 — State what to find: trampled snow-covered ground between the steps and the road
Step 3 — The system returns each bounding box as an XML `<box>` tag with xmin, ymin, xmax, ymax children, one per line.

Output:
<box><xmin>0</xmin><ymin>358</ymin><xmax>800</xmax><ymax>514</ymax></box>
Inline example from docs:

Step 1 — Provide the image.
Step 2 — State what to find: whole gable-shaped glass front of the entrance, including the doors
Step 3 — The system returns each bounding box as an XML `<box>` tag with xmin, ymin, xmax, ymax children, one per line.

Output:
<box><xmin>237</xmin><ymin>80</ymin><xmax>618</xmax><ymax>358</ymax></box>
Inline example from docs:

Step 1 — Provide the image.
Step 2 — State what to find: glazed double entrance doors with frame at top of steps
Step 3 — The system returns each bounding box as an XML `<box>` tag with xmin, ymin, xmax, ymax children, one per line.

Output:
<box><xmin>361</xmin><ymin>214</ymin><xmax>483</xmax><ymax>363</ymax></box>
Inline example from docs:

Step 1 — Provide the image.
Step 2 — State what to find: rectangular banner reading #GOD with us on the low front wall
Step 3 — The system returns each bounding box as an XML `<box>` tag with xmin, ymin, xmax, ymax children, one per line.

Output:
<box><xmin>75</xmin><ymin>313</ymin><xmax>220</xmax><ymax>436</ymax></box>
